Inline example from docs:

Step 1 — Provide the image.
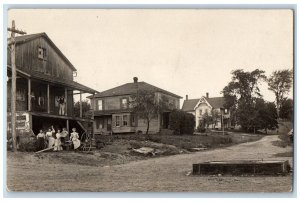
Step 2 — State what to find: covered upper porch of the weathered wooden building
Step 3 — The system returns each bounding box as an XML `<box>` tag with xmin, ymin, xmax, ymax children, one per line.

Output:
<box><xmin>7</xmin><ymin>68</ymin><xmax>97</xmax><ymax>118</ymax></box>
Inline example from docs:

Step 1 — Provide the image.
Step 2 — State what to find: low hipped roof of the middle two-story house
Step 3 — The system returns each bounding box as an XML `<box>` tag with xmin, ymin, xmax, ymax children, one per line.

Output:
<box><xmin>88</xmin><ymin>81</ymin><xmax>182</xmax><ymax>98</ymax></box>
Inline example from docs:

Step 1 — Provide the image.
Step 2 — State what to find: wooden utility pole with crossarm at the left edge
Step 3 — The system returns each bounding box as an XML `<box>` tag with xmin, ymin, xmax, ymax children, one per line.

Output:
<box><xmin>7</xmin><ymin>20</ymin><xmax>26</xmax><ymax>152</ymax></box>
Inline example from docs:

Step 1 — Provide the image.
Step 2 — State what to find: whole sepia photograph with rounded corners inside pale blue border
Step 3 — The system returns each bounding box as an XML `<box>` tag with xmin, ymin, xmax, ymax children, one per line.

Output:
<box><xmin>3</xmin><ymin>7</ymin><xmax>296</xmax><ymax>194</ymax></box>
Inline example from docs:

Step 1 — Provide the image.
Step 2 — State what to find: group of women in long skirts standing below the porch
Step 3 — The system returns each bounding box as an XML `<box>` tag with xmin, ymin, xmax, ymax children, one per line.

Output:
<box><xmin>36</xmin><ymin>126</ymin><xmax>80</xmax><ymax>151</ymax></box>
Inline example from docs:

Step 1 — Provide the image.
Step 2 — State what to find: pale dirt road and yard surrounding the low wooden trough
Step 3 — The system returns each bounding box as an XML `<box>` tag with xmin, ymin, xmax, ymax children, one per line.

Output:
<box><xmin>7</xmin><ymin>136</ymin><xmax>292</xmax><ymax>192</ymax></box>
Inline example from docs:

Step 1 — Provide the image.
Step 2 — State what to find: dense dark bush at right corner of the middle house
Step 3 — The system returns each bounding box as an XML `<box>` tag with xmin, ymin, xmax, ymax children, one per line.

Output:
<box><xmin>170</xmin><ymin>110</ymin><xmax>195</xmax><ymax>135</ymax></box>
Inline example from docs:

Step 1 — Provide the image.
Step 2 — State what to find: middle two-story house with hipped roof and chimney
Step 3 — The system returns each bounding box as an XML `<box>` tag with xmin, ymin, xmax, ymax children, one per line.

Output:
<box><xmin>89</xmin><ymin>77</ymin><xmax>181</xmax><ymax>134</ymax></box>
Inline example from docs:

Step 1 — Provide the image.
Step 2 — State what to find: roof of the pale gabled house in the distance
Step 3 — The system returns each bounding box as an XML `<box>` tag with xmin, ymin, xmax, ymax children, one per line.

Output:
<box><xmin>182</xmin><ymin>97</ymin><xmax>225</xmax><ymax>112</ymax></box>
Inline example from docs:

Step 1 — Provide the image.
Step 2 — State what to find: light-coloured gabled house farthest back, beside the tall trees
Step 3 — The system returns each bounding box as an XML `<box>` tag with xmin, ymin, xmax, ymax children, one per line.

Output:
<box><xmin>182</xmin><ymin>93</ymin><xmax>231</xmax><ymax>129</ymax></box>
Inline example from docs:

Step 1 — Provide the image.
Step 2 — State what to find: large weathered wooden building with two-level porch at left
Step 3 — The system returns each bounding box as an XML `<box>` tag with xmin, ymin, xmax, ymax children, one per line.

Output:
<box><xmin>7</xmin><ymin>33</ymin><xmax>97</xmax><ymax>143</ymax></box>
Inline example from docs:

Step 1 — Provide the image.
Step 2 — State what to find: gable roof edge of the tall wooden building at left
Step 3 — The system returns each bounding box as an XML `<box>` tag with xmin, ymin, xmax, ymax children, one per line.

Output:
<box><xmin>9</xmin><ymin>32</ymin><xmax>77</xmax><ymax>71</ymax></box>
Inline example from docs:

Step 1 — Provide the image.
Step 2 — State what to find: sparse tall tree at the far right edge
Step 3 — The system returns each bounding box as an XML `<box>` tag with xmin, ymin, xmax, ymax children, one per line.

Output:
<box><xmin>268</xmin><ymin>69</ymin><xmax>293</xmax><ymax>117</ymax></box>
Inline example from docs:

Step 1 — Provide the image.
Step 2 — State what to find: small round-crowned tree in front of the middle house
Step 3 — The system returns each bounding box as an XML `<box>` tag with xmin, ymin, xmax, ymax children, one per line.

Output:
<box><xmin>130</xmin><ymin>90</ymin><xmax>169</xmax><ymax>135</ymax></box>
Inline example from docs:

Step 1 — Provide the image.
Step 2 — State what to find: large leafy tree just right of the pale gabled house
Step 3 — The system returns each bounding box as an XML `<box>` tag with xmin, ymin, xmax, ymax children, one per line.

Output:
<box><xmin>222</xmin><ymin>69</ymin><xmax>266</xmax><ymax>132</ymax></box>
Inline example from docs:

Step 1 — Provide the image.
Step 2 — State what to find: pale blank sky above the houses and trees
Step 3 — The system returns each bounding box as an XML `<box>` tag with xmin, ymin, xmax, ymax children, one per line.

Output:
<box><xmin>8</xmin><ymin>9</ymin><xmax>293</xmax><ymax>104</ymax></box>
